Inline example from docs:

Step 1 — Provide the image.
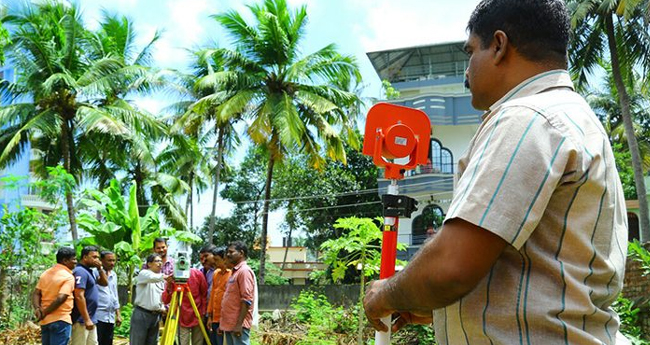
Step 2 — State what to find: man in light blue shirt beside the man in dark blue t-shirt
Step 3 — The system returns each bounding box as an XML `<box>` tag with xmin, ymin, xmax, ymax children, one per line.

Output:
<box><xmin>96</xmin><ymin>251</ymin><xmax>122</xmax><ymax>345</ymax></box>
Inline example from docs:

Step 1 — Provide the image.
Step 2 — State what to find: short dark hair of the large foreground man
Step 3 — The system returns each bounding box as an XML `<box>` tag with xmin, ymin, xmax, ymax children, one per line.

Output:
<box><xmin>467</xmin><ymin>0</ymin><xmax>571</xmax><ymax>66</ymax></box>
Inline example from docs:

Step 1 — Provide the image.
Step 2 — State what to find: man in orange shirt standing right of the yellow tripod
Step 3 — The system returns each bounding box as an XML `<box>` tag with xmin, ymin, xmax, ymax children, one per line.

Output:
<box><xmin>208</xmin><ymin>247</ymin><xmax>232</xmax><ymax>345</ymax></box>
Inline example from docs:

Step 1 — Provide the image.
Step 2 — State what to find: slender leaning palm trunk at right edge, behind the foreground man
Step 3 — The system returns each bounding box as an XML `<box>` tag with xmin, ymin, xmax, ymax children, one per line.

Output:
<box><xmin>605</xmin><ymin>13</ymin><xmax>650</xmax><ymax>242</ymax></box>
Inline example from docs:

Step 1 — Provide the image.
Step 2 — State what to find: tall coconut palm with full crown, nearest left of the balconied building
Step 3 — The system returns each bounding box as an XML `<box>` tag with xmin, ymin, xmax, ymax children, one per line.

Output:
<box><xmin>211</xmin><ymin>0</ymin><xmax>361</xmax><ymax>283</ymax></box>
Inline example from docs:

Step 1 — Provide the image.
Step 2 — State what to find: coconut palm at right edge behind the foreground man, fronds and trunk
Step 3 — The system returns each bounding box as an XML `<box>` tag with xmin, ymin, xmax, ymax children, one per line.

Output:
<box><xmin>567</xmin><ymin>0</ymin><xmax>650</xmax><ymax>241</ymax></box>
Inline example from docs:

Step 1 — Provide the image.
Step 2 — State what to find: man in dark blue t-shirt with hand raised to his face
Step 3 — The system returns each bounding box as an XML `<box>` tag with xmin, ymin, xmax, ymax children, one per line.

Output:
<box><xmin>70</xmin><ymin>246</ymin><xmax>108</xmax><ymax>345</ymax></box>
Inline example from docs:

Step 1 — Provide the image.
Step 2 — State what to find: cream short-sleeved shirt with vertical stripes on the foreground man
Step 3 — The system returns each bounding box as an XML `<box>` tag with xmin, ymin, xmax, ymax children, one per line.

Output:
<box><xmin>434</xmin><ymin>70</ymin><xmax>627</xmax><ymax>344</ymax></box>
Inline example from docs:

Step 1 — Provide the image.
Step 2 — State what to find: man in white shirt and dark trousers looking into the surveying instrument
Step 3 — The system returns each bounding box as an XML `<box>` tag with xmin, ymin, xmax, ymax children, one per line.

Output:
<box><xmin>129</xmin><ymin>254</ymin><xmax>170</xmax><ymax>345</ymax></box>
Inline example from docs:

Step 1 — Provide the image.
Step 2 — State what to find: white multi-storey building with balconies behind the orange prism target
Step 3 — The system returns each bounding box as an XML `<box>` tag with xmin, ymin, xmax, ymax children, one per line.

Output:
<box><xmin>367</xmin><ymin>42</ymin><xmax>482</xmax><ymax>258</ymax></box>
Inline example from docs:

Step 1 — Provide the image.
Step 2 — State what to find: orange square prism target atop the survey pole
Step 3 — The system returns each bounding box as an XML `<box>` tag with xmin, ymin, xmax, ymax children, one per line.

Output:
<box><xmin>363</xmin><ymin>103</ymin><xmax>431</xmax><ymax>180</ymax></box>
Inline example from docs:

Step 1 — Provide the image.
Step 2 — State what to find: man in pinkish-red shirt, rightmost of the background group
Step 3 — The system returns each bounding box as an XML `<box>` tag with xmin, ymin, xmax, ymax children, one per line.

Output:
<box><xmin>219</xmin><ymin>241</ymin><xmax>255</xmax><ymax>345</ymax></box>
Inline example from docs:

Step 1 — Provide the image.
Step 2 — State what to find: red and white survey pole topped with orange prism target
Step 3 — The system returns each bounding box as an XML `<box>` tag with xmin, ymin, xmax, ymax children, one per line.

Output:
<box><xmin>363</xmin><ymin>103</ymin><xmax>431</xmax><ymax>345</ymax></box>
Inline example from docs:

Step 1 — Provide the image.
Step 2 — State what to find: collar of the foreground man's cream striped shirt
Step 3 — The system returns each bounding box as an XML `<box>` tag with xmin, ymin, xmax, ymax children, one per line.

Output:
<box><xmin>483</xmin><ymin>69</ymin><xmax>574</xmax><ymax>118</ymax></box>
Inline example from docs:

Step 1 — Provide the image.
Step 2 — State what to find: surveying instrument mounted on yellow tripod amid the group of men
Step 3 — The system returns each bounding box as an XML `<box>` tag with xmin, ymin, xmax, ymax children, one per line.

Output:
<box><xmin>160</xmin><ymin>247</ymin><xmax>212</xmax><ymax>345</ymax></box>
